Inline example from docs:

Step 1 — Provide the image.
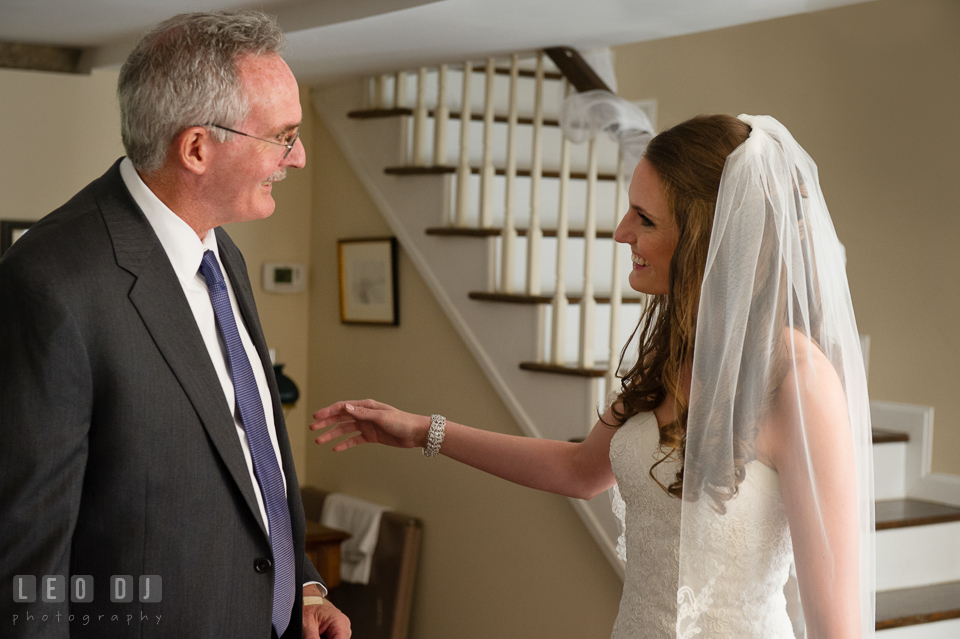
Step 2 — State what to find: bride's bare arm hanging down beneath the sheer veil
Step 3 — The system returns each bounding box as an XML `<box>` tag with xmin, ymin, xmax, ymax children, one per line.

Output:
<box><xmin>757</xmin><ymin>349</ymin><xmax>861</xmax><ymax>639</ymax></box>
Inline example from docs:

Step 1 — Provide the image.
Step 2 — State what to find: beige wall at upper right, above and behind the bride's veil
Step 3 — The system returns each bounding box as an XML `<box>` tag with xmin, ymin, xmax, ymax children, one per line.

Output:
<box><xmin>615</xmin><ymin>0</ymin><xmax>960</xmax><ymax>474</ymax></box>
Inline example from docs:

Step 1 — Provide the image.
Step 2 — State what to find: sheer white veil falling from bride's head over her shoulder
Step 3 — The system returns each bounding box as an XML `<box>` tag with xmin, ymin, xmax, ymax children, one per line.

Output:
<box><xmin>677</xmin><ymin>115</ymin><xmax>875</xmax><ymax>638</ymax></box>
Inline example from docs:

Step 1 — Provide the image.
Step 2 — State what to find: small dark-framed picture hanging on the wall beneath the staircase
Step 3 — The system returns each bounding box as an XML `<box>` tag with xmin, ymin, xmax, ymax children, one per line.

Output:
<box><xmin>337</xmin><ymin>237</ymin><xmax>400</xmax><ymax>326</ymax></box>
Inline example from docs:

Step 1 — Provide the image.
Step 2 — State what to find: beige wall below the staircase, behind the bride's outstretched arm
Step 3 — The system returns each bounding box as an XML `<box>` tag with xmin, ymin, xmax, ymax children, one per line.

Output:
<box><xmin>307</xmin><ymin>116</ymin><xmax>621</xmax><ymax>639</ymax></box>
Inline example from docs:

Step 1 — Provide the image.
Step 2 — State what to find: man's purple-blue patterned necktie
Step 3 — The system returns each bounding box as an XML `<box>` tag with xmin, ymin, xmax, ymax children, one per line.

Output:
<box><xmin>200</xmin><ymin>250</ymin><xmax>295</xmax><ymax>637</ymax></box>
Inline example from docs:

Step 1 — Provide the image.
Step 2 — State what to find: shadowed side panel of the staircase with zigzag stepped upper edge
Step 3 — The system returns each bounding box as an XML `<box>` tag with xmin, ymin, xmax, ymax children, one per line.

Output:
<box><xmin>312</xmin><ymin>80</ymin><xmax>624</xmax><ymax>579</ymax></box>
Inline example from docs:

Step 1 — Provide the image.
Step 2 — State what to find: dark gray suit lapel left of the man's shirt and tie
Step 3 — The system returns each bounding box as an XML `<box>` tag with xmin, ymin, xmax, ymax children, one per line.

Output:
<box><xmin>97</xmin><ymin>163</ymin><xmax>266</xmax><ymax>535</ymax></box>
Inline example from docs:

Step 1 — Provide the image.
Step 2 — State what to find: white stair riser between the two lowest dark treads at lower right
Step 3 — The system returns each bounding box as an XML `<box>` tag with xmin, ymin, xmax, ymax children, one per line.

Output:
<box><xmin>877</xmin><ymin>522</ymin><xmax>960</xmax><ymax>591</ymax></box>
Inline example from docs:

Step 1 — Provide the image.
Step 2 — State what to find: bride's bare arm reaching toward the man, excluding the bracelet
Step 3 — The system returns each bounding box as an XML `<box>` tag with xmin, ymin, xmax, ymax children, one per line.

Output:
<box><xmin>310</xmin><ymin>399</ymin><xmax>616</xmax><ymax>499</ymax></box>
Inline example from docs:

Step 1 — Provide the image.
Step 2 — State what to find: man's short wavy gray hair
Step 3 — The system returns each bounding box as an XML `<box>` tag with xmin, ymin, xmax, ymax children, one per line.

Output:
<box><xmin>117</xmin><ymin>11</ymin><xmax>286</xmax><ymax>173</ymax></box>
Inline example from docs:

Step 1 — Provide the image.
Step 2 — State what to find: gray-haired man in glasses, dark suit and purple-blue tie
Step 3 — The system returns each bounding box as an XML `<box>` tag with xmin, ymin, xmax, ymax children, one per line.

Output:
<box><xmin>0</xmin><ymin>11</ymin><xmax>350</xmax><ymax>639</ymax></box>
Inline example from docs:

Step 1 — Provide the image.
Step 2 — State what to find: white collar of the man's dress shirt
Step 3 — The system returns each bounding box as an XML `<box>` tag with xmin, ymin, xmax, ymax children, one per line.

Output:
<box><xmin>120</xmin><ymin>158</ymin><xmax>220</xmax><ymax>286</ymax></box>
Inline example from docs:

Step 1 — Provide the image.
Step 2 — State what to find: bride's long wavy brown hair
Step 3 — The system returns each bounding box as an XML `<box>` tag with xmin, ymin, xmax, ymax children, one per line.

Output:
<box><xmin>611</xmin><ymin>115</ymin><xmax>752</xmax><ymax>498</ymax></box>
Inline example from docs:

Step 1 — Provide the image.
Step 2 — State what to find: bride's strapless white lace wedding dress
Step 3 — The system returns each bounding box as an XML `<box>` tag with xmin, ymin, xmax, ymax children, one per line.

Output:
<box><xmin>610</xmin><ymin>413</ymin><xmax>794</xmax><ymax>639</ymax></box>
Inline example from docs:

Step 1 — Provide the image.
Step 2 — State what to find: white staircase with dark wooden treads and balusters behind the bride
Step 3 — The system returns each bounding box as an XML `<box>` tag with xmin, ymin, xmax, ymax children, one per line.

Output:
<box><xmin>313</xmin><ymin>48</ymin><xmax>960</xmax><ymax>639</ymax></box>
